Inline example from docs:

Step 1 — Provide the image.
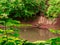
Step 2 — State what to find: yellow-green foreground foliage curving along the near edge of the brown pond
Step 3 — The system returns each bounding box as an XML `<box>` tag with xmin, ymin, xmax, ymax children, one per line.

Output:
<box><xmin>0</xmin><ymin>29</ymin><xmax>60</xmax><ymax>45</ymax></box>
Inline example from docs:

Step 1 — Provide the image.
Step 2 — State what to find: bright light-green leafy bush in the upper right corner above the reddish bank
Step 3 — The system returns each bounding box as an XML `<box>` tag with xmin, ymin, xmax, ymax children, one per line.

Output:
<box><xmin>47</xmin><ymin>0</ymin><xmax>60</xmax><ymax>18</ymax></box>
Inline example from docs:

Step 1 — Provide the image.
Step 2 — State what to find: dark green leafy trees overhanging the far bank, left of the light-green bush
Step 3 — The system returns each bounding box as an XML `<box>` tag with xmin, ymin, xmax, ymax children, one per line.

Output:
<box><xmin>0</xmin><ymin>0</ymin><xmax>45</xmax><ymax>20</ymax></box>
